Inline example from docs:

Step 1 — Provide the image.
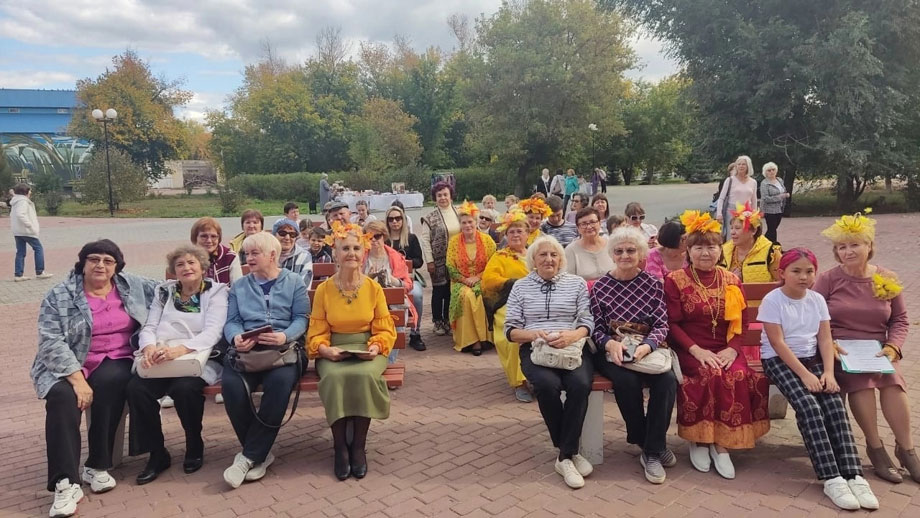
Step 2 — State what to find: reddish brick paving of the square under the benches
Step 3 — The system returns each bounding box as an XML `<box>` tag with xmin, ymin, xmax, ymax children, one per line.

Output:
<box><xmin>0</xmin><ymin>214</ymin><xmax>920</xmax><ymax>518</ymax></box>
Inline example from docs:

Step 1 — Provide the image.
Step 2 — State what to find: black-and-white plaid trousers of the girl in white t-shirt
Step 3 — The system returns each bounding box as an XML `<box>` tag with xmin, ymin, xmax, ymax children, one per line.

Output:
<box><xmin>761</xmin><ymin>356</ymin><xmax>862</xmax><ymax>480</ymax></box>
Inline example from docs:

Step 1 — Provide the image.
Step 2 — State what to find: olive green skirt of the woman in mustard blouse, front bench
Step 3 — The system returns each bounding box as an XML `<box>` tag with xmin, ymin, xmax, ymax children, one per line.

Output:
<box><xmin>316</xmin><ymin>333</ymin><xmax>390</xmax><ymax>425</ymax></box>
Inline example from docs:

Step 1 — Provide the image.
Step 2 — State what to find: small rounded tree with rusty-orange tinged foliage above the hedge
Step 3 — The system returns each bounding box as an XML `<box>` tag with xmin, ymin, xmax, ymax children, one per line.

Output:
<box><xmin>348</xmin><ymin>98</ymin><xmax>422</xmax><ymax>171</ymax></box>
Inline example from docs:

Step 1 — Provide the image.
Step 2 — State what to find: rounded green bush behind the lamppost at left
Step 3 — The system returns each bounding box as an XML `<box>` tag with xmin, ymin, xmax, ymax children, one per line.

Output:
<box><xmin>80</xmin><ymin>149</ymin><xmax>147</xmax><ymax>209</ymax></box>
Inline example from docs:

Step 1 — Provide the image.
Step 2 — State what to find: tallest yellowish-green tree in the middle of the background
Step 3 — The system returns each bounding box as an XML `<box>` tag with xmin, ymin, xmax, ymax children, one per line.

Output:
<box><xmin>464</xmin><ymin>0</ymin><xmax>634</xmax><ymax>194</ymax></box>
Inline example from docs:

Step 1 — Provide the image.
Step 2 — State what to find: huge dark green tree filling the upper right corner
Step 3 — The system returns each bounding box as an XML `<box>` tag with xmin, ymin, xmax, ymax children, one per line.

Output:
<box><xmin>602</xmin><ymin>0</ymin><xmax>920</xmax><ymax>209</ymax></box>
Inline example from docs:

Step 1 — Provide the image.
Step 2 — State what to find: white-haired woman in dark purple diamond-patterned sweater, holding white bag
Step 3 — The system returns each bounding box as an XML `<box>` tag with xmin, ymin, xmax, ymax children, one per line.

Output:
<box><xmin>591</xmin><ymin>228</ymin><xmax>677</xmax><ymax>484</ymax></box>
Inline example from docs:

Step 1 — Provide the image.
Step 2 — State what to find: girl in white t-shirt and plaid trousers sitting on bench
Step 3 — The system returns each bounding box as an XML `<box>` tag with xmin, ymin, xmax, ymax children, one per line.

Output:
<box><xmin>757</xmin><ymin>248</ymin><xmax>878</xmax><ymax>510</ymax></box>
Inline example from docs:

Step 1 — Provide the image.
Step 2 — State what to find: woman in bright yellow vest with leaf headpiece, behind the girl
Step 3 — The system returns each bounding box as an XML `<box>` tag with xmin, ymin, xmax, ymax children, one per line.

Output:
<box><xmin>719</xmin><ymin>204</ymin><xmax>782</xmax><ymax>282</ymax></box>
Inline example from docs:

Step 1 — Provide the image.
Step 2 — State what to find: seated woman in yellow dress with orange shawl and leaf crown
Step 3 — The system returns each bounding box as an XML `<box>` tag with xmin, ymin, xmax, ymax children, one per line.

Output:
<box><xmin>447</xmin><ymin>201</ymin><xmax>495</xmax><ymax>356</ymax></box>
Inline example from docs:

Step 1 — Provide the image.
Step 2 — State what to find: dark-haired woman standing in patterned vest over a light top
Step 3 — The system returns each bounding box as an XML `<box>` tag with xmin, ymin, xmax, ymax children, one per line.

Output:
<box><xmin>421</xmin><ymin>181</ymin><xmax>460</xmax><ymax>336</ymax></box>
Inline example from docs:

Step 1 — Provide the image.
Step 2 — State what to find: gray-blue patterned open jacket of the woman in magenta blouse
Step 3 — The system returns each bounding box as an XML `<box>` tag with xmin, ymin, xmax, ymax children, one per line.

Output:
<box><xmin>31</xmin><ymin>271</ymin><xmax>156</xmax><ymax>399</ymax></box>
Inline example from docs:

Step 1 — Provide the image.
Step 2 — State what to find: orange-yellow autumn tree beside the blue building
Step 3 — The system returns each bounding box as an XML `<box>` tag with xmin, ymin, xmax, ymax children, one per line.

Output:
<box><xmin>68</xmin><ymin>50</ymin><xmax>192</xmax><ymax>180</ymax></box>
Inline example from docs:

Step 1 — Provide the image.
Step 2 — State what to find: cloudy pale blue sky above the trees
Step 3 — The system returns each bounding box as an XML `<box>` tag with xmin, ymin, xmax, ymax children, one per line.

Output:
<box><xmin>0</xmin><ymin>0</ymin><xmax>676</xmax><ymax>118</ymax></box>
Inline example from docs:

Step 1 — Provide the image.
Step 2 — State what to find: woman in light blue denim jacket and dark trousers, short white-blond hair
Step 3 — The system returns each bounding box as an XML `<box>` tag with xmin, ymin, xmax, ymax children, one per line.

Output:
<box><xmin>221</xmin><ymin>232</ymin><xmax>310</xmax><ymax>489</ymax></box>
